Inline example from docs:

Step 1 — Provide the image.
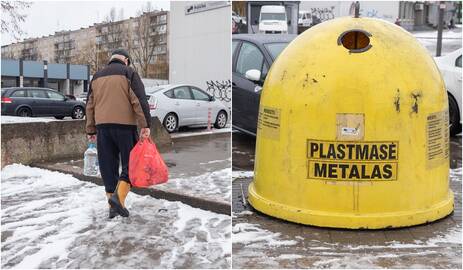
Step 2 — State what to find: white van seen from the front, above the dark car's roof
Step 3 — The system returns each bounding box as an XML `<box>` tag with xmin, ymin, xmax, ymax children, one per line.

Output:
<box><xmin>259</xmin><ymin>6</ymin><xmax>288</xmax><ymax>34</ymax></box>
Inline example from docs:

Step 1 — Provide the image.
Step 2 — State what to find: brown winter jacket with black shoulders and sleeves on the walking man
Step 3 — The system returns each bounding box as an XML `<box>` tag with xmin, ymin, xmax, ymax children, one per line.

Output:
<box><xmin>86</xmin><ymin>59</ymin><xmax>151</xmax><ymax>135</ymax></box>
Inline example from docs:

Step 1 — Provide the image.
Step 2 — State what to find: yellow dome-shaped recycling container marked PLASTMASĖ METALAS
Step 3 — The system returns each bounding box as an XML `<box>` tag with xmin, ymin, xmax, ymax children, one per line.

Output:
<box><xmin>249</xmin><ymin>17</ymin><xmax>453</xmax><ymax>229</ymax></box>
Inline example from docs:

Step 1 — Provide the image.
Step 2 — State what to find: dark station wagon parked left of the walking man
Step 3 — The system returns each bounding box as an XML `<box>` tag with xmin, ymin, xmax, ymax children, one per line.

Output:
<box><xmin>1</xmin><ymin>87</ymin><xmax>85</xmax><ymax>119</ymax></box>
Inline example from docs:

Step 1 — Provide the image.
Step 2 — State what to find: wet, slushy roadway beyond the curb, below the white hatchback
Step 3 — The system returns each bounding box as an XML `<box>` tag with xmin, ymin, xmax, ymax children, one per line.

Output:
<box><xmin>49</xmin><ymin>135</ymin><xmax>232</xmax><ymax>204</ymax></box>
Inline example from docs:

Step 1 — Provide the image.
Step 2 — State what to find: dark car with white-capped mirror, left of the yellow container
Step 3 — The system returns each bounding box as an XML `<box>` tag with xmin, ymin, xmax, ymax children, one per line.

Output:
<box><xmin>232</xmin><ymin>34</ymin><xmax>296</xmax><ymax>136</ymax></box>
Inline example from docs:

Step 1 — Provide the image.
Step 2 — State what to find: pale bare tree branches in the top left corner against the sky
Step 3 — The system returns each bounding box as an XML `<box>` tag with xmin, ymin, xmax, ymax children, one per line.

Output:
<box><xmin>1</xmin><ymin>0</ymin><xmax>31</xmax><ymax>40</ymax></box>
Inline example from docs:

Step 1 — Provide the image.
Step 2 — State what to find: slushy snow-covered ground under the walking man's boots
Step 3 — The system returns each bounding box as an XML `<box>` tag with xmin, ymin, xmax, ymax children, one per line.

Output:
<box><xmin>1</xmin><ymin>164</ymin><xmax>231</xmax><ymax>268</ymax></box>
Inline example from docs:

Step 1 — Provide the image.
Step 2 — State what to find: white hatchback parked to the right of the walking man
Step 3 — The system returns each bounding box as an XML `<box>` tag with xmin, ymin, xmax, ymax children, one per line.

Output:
<box><xmin>145</xmin><ymin>84</ymin><xmax>230</xmax><ymax>132</ymax></box>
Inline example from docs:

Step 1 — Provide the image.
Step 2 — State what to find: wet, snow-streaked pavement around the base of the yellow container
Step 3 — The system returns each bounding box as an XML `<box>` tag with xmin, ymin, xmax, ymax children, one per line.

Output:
<box><xmin>232</xmin><ymin>132</ymin><xmax>462</xmax><ymax>269</ymax></box>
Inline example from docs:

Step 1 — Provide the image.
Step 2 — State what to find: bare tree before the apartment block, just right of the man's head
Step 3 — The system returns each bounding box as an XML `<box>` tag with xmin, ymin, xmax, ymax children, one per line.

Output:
<box><xmin>129</xmin><ymin>2</ymin><xmax>160</xmax><ymax>78</ymax></box>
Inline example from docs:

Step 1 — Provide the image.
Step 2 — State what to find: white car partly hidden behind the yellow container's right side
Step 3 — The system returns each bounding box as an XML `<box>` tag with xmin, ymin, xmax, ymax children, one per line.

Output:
<box><xmin>434</xmin><ymin>48</ymin><xmax>462</xmax><ymax>135</ymax></box>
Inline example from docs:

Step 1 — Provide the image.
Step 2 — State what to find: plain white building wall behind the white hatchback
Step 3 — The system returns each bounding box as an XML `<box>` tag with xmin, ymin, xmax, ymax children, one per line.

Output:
<box><xmin>169</xmin><ymin>1</ymin><xmax>231</xmax><ymax>105</ymax></box>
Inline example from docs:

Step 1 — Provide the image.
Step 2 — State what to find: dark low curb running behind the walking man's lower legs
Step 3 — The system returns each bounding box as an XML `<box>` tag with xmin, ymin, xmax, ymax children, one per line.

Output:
<box><xmin>30</xmin><ymin>164</ymin><xmax>231</xmax><ymax>216</ymax></box>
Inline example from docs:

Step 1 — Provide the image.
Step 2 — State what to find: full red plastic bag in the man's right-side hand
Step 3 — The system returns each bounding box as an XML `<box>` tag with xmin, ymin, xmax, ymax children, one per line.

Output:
<box><xmin>129</xmin><ymin>138</ymin><xmax>169</xmax><ymax>187</ymax></box>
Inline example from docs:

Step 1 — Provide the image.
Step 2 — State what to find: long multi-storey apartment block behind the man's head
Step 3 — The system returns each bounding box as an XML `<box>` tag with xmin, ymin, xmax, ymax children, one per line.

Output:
<box><xmin>1</xmin><ymin>10</ymin><xmax>169</xmax><ymax>80</ymax></box>
